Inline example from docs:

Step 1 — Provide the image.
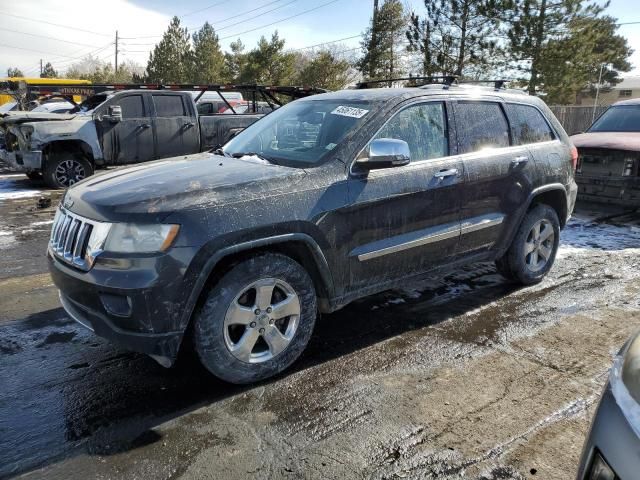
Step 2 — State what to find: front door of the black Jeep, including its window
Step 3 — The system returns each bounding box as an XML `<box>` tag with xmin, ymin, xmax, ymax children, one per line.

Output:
<box><xmin>345</xmin><ymin>102</ymin><xmax>464</xmax><ymax>290</ymax></box>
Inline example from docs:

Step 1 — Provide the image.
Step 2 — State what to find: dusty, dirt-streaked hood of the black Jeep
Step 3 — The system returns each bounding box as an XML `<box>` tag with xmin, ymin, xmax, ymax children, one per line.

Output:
<box><xmin>63</xmin><ymin>153</ymin><xmax>306</xmax><ymax>222</ymax></box>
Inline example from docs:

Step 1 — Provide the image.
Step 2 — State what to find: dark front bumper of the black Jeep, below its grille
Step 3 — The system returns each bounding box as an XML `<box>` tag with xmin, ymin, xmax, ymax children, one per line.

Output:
<box><xmin>47</xmin><ymin>248</ymin><xmax>198</xmax><ymax>366</ymax></box>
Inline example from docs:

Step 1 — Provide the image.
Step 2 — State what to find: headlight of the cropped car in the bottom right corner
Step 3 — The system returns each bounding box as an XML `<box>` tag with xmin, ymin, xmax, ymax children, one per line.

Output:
<box><xmin>609</xmin><ymin>334</ymin><xmax>640</xmax><ymax>437</ymax></box>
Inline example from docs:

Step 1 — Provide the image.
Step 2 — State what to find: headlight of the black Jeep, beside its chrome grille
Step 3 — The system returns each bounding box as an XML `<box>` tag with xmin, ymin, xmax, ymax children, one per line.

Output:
<box><xmin>103</xmin><ymin>223</ymin><xmax>180</xmax><ymax>253</ymax></box>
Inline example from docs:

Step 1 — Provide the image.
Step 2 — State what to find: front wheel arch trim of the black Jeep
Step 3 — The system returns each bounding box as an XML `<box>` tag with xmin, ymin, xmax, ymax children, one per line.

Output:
<box><xmin>180</xmin><ymin>233</ymin><xmax>334</xmax><ymax>332</ymax></box>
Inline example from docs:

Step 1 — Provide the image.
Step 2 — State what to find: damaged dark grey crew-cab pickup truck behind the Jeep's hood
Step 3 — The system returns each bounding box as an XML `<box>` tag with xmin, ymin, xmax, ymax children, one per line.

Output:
<box><xmin>0</xmin><ymin>86</ymin><xmax>316</xmax><ymax>188</ymax></box>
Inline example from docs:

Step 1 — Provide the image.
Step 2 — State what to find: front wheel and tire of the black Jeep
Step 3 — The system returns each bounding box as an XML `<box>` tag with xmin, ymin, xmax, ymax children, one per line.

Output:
<box><xmin>193</xmin><ymin>253</ymin><xmax>317</xmax><ymax>384</ymax></box>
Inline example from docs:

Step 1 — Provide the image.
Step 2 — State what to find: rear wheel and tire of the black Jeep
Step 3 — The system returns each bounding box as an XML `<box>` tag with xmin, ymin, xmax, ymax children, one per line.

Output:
<box><xmin>496</xmin><ymin>204</ymin><xmax>560</xmax><ymax>285</ymax></box>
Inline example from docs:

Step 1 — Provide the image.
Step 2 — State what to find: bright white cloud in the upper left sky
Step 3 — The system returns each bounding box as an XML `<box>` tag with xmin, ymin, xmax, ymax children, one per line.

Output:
<box><xmin>0</xmin><ymin>0</ymin><xmax>170</xmax><ymax>76</ymax></box>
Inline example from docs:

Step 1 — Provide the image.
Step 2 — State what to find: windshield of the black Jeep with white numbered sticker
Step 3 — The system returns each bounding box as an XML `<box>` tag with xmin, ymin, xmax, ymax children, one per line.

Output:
<box><xmin>223</xmin><ymin>100</ymin><xmax>371</xmax><ymax>168</ymax></box>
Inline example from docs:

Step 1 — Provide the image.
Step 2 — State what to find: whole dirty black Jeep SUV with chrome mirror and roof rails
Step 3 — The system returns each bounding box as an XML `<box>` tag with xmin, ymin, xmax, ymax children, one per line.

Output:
<box><xmin>48</xmin><ymin>85</ymin><xmax>576</xmax><ymax>383</ymax></box>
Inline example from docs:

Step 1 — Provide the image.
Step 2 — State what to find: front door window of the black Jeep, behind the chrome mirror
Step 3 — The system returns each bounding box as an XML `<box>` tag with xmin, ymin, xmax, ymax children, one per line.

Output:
<box><xmin>374</xmin><ymin>102</ymin><xmax>449</xmax><ymax>161</ymax></box>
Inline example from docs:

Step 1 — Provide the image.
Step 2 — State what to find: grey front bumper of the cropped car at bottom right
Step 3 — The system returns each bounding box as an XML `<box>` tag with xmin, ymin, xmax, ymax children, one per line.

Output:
<box><xmin>577</xmin><ymin>382</ymin><xmax>640</xmax><ymax>480</ymax></box>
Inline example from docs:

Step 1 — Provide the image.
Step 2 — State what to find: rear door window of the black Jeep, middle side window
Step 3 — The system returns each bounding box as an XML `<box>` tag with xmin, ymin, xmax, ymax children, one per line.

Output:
<box><xmin>456</xmin><ymin>102</ymin><xmax>509</xmax><ymax>153</ymax></box>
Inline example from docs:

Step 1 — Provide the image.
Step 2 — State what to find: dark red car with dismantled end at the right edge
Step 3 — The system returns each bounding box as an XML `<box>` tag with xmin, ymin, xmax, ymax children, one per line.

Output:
<box><xmin>571</xmin><ymin>99</ymin><xmax>640</xmax><ymax>208</ymax></box>
